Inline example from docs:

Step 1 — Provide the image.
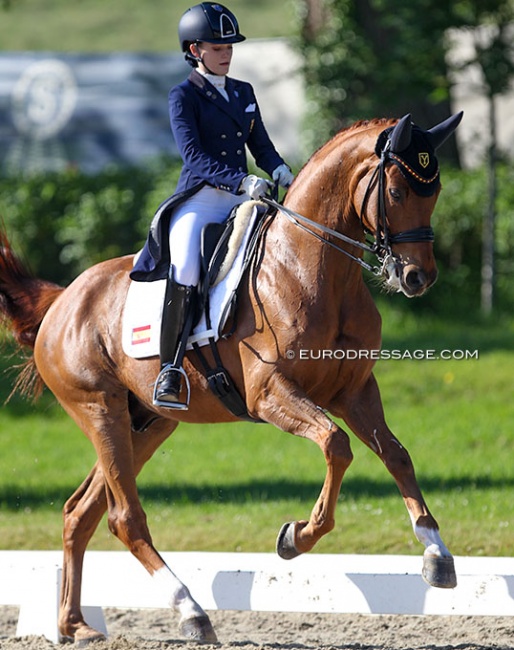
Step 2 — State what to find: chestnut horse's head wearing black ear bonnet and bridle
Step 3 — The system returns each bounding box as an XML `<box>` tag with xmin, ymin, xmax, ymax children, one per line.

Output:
<box><xmin>358</xmin><ymin>112</ymin><xmax>462</xmax><ymax>297</ymax></box>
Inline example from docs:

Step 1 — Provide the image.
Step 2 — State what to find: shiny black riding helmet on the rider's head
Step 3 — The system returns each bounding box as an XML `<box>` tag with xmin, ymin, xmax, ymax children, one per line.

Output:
<box><xmin>178</xmin><ymin>2</ymin><xmax>246</xmax><ymax>67</ymax></box>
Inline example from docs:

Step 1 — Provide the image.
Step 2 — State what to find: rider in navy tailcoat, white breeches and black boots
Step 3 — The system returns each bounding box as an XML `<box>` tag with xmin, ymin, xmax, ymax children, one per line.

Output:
<box><xmin>131</xmin><ymin>2</ymin><xmax>294</xmax><ymax>409</ymax></box>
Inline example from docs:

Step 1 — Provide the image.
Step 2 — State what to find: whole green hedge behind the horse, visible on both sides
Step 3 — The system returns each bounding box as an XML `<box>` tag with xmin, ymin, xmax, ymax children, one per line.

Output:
<box><xmin>0</xmin><ymin>160</ymin><xmax>514</xmax><ymax>315</ymax></box>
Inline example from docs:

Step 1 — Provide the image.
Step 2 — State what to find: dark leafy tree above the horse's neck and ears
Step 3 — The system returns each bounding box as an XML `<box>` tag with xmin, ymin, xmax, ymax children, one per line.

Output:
<box><xmin>300</xmin><ymin>0</ymin><xmax>458</xmax><ymax>163</ymax></box>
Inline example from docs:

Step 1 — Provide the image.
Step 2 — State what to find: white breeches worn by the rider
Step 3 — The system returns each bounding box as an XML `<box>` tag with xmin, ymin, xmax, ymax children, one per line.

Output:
<box><xmin>169</xmin><ymin>187</ymin><xmax>248</xmax><ymax>286</ymax></box>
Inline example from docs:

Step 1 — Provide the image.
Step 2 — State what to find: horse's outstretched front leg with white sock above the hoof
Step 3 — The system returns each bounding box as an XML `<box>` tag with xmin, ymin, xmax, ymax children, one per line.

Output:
<box><xmin>330</xmin><ymin>375</ymin><xmax>457</xmax><ymax>588</ymax></box>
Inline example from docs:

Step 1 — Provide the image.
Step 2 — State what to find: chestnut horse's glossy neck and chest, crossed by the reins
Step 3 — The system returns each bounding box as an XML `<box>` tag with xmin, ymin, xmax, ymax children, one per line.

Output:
<box><xmin>250</xmin><ymin>128</ymin><xmax>380</xmax><ymax>345</ymax></box>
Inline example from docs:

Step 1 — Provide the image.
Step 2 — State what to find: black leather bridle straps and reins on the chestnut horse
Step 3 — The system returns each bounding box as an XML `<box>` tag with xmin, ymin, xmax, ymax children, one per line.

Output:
<box><xmin>262</xmin><ymin>139</ymin><xmax>434</xmax><ymax>276</ymax></box>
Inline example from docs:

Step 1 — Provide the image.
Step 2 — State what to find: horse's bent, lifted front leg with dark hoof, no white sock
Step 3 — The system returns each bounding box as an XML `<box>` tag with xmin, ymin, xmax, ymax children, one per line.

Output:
<box><xmin>252</xmin><ymin>373</ymin><xmax>353</xmax><ymax>559</ymax></box>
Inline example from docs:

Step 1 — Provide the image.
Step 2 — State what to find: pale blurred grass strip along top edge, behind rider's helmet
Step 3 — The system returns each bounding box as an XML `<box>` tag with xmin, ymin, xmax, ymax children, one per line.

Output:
<box><xmin>0</xmin><ymin>0</ymin><xmax>296</xmax><ymax>52</ymax></box>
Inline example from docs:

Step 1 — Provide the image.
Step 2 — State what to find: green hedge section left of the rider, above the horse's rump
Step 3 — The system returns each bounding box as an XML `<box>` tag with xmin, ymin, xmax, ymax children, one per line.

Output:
<box><xmin>0</xmin><ymin>161</ymin><xmax>180</xmax><ymax>284</ymax></box>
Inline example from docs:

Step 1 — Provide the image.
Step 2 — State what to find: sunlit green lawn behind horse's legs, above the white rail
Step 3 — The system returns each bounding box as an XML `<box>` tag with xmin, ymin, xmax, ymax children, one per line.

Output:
<box><xmin>0</xmin><ymin>302</ymin><xmax>514</xmax><ymax>556</ymax></box>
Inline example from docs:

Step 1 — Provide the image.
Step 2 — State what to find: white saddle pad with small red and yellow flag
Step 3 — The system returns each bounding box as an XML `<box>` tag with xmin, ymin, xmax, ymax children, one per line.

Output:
<box><xmin>122</xmin><ymin>202</ymin><xmax>258</xmax><ymax>359</ymax></box>
